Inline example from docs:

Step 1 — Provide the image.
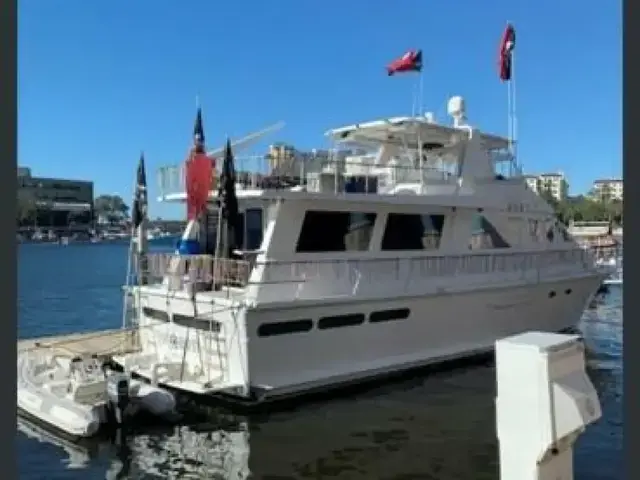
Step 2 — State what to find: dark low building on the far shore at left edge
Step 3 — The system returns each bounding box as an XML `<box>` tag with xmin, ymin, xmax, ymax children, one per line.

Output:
<box><xmin>17</xmin><ymin>167</ymin><xmax>93</xmax><ymax>227</ymax></box>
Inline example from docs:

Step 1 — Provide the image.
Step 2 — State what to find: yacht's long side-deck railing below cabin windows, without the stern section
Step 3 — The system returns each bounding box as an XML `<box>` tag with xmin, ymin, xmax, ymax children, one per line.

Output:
<box><xmin>254</xmin><ymin>249</ymin><xmax>594</xmax><ymax>302</ymax></box>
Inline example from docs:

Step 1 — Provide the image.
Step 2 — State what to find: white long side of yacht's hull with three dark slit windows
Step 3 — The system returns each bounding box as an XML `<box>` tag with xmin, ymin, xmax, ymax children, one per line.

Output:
<box><xmin>129</xmin><ymin>274</ymin><xmax>603</xmax><ymax>404</ymax></box>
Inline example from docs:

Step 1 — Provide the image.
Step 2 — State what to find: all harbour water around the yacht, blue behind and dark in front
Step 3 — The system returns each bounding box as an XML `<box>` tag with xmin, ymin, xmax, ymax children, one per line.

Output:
<box><xmin>17</xmin><ymin>244</ymin><xmax>624</xmax><ymax>480</ymax></box>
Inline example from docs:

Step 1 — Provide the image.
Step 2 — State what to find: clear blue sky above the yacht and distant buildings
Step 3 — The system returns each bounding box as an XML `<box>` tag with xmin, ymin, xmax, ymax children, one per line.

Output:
<box><xmin>18</xmin><ymin>0</ymin><xmax>622</xmax><ymax>218</ymax></box>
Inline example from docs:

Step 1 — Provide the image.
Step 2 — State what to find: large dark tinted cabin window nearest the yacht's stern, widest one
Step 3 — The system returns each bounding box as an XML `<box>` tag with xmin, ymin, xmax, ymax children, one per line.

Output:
<box><xmin>296</xmin><ymin>210</ymin><xmax>376</xmax><ymax>252</ymax></box>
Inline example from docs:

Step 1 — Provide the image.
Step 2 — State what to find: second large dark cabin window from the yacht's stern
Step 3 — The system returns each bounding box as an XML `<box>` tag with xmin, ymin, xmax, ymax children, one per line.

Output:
<box><xmin>382</xmin><ymin>213</ymin><xmax>444</xmax><ymax>250</ymax></box>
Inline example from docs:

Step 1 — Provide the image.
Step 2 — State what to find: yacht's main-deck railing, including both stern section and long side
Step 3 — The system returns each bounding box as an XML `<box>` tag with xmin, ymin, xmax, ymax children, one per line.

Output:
<box><xmin>141</xmin><ymin>249</ymin><xmax>594</xmax><ymax>301</ymax></box>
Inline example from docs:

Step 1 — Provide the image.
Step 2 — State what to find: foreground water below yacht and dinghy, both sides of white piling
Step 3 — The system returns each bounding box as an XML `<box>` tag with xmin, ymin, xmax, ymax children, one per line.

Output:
<box><xmin>17</xmin><ymin>291</ymin><xmax>623</xmax><ymax>480</ymax></box>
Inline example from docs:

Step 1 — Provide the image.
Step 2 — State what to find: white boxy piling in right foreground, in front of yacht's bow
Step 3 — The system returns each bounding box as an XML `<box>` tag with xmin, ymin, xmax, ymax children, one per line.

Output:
<box><xmin>496</xmin><ymin>332</ymin><xmax>602</xmax><ymax>480</ymax></box>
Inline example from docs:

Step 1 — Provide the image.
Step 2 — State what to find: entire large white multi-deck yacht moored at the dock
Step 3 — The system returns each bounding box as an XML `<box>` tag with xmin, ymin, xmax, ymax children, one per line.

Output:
<box><xmin>118</xmin><ymin>97</ymin><xmax>603</xmax><ymax>401</ymax></box>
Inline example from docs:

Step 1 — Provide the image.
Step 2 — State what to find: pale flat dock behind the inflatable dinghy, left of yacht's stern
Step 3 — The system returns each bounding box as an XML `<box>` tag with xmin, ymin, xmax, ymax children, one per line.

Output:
<box><xmin>18</xmin><ymin>328</ymin><xmax>139</xmax><ymax>356</ymax></box>
